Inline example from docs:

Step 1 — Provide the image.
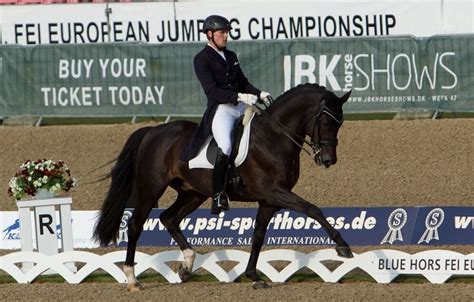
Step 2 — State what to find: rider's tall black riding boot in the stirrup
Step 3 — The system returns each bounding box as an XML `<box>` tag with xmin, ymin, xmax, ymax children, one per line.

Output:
<box><xmin>211</xmin><ymin>148</ymin><xmax>229</xmax><ymax>215</ymax></box>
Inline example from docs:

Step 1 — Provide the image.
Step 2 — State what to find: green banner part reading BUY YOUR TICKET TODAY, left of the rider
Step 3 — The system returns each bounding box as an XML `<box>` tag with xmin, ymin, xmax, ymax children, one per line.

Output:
<box><xmin>0</xmin><ymin>44</ymin><xmax>200</xmax><ymax>116</ymax></box>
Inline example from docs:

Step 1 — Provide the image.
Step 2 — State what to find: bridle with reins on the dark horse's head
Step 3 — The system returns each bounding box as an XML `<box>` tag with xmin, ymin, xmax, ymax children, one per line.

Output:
<box><xmin>258</xmin><ymin>99</ymin><xmax>344</xmax><ymax>158</ymax></box>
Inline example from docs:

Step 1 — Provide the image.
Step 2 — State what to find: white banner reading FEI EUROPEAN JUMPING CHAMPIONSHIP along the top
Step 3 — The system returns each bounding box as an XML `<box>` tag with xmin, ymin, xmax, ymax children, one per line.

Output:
<box><xmin>0</xmin><ymin>0</ymin><xmax>474</xmax><ymax>45</ymax></box>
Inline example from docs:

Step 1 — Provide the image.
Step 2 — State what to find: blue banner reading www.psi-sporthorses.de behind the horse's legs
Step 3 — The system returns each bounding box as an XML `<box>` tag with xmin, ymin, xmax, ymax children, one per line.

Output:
<box><xmin>117</xmin><ymin>207</ymin><xmax>474</xmax><ymax>246</ymax></box>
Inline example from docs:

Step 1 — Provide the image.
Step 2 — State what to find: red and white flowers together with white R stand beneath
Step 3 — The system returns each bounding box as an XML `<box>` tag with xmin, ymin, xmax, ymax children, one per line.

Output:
<box><xmin>8</xmin><ymin>159</ymin><xmax>77</xmax><ymax>274</ymax></box>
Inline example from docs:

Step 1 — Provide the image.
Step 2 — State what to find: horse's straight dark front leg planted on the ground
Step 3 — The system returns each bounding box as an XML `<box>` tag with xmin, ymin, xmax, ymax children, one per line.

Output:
<box><xmin>245</xmin><ymin>202</ymin><xmax>279</xmax><ymax>289</ymax></box>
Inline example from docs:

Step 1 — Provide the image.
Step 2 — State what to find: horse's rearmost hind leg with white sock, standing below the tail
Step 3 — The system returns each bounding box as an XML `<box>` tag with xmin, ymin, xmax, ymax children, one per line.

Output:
<box><xmin>123</xmin><ymin>186</ymin><xmax>166</xmax><ymax>292</ymax></box>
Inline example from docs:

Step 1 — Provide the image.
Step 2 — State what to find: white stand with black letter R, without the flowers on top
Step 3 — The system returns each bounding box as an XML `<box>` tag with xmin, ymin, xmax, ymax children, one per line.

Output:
<box><xmin>16</xmin><ymin>197</ymin><xmax>77</xmax><ymax>273</ymax></box>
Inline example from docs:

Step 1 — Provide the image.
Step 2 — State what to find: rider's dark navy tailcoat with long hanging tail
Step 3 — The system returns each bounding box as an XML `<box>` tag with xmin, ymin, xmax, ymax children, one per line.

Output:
<box><xmin>180</xmin><ymin>45</ymin><xmax>261</xmax><ymax>161</ymax></box>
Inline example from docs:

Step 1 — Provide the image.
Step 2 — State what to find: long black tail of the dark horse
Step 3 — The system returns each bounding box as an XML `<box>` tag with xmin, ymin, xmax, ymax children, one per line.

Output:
<box><xmin>94</xmin><ymin>127</ymin><xmax>152</xmax><ymax>246</ymax></box>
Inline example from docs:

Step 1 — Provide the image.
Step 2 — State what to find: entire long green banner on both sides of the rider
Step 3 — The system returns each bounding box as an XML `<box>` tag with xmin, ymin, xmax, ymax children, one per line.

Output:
<box><xmin>0</xmin><ymin>35</ymin><xmax>474</xmax><ymax>117</ymax></box>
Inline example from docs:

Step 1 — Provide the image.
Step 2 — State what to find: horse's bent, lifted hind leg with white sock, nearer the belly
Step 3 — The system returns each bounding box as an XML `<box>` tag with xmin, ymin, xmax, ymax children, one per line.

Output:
<box><xmin>160</xmin><ymin>191</ymin><xmax>207</xmax><ymax>282</ymax></box>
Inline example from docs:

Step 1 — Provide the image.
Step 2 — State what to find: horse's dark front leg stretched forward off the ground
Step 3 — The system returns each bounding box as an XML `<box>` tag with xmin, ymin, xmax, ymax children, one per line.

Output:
<box><xmin>267</xmin><ymin>187</ymin><xmax>354</xmax><ymax>258</ymax></box>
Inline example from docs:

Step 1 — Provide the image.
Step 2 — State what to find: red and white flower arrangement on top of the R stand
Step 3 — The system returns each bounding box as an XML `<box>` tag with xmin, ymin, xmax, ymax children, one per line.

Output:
<box><xmin>8</xmin><ymin>159</ymin><xmax>77</xmax><ymax>200</ymax></box>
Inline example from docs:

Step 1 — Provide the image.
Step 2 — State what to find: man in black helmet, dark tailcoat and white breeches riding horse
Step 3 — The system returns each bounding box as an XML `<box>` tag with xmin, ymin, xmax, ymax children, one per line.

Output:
<box><xmin>181</xmin><ymin>15</ymin><xmax>271</xmax><ymax>214</ymax></box>
